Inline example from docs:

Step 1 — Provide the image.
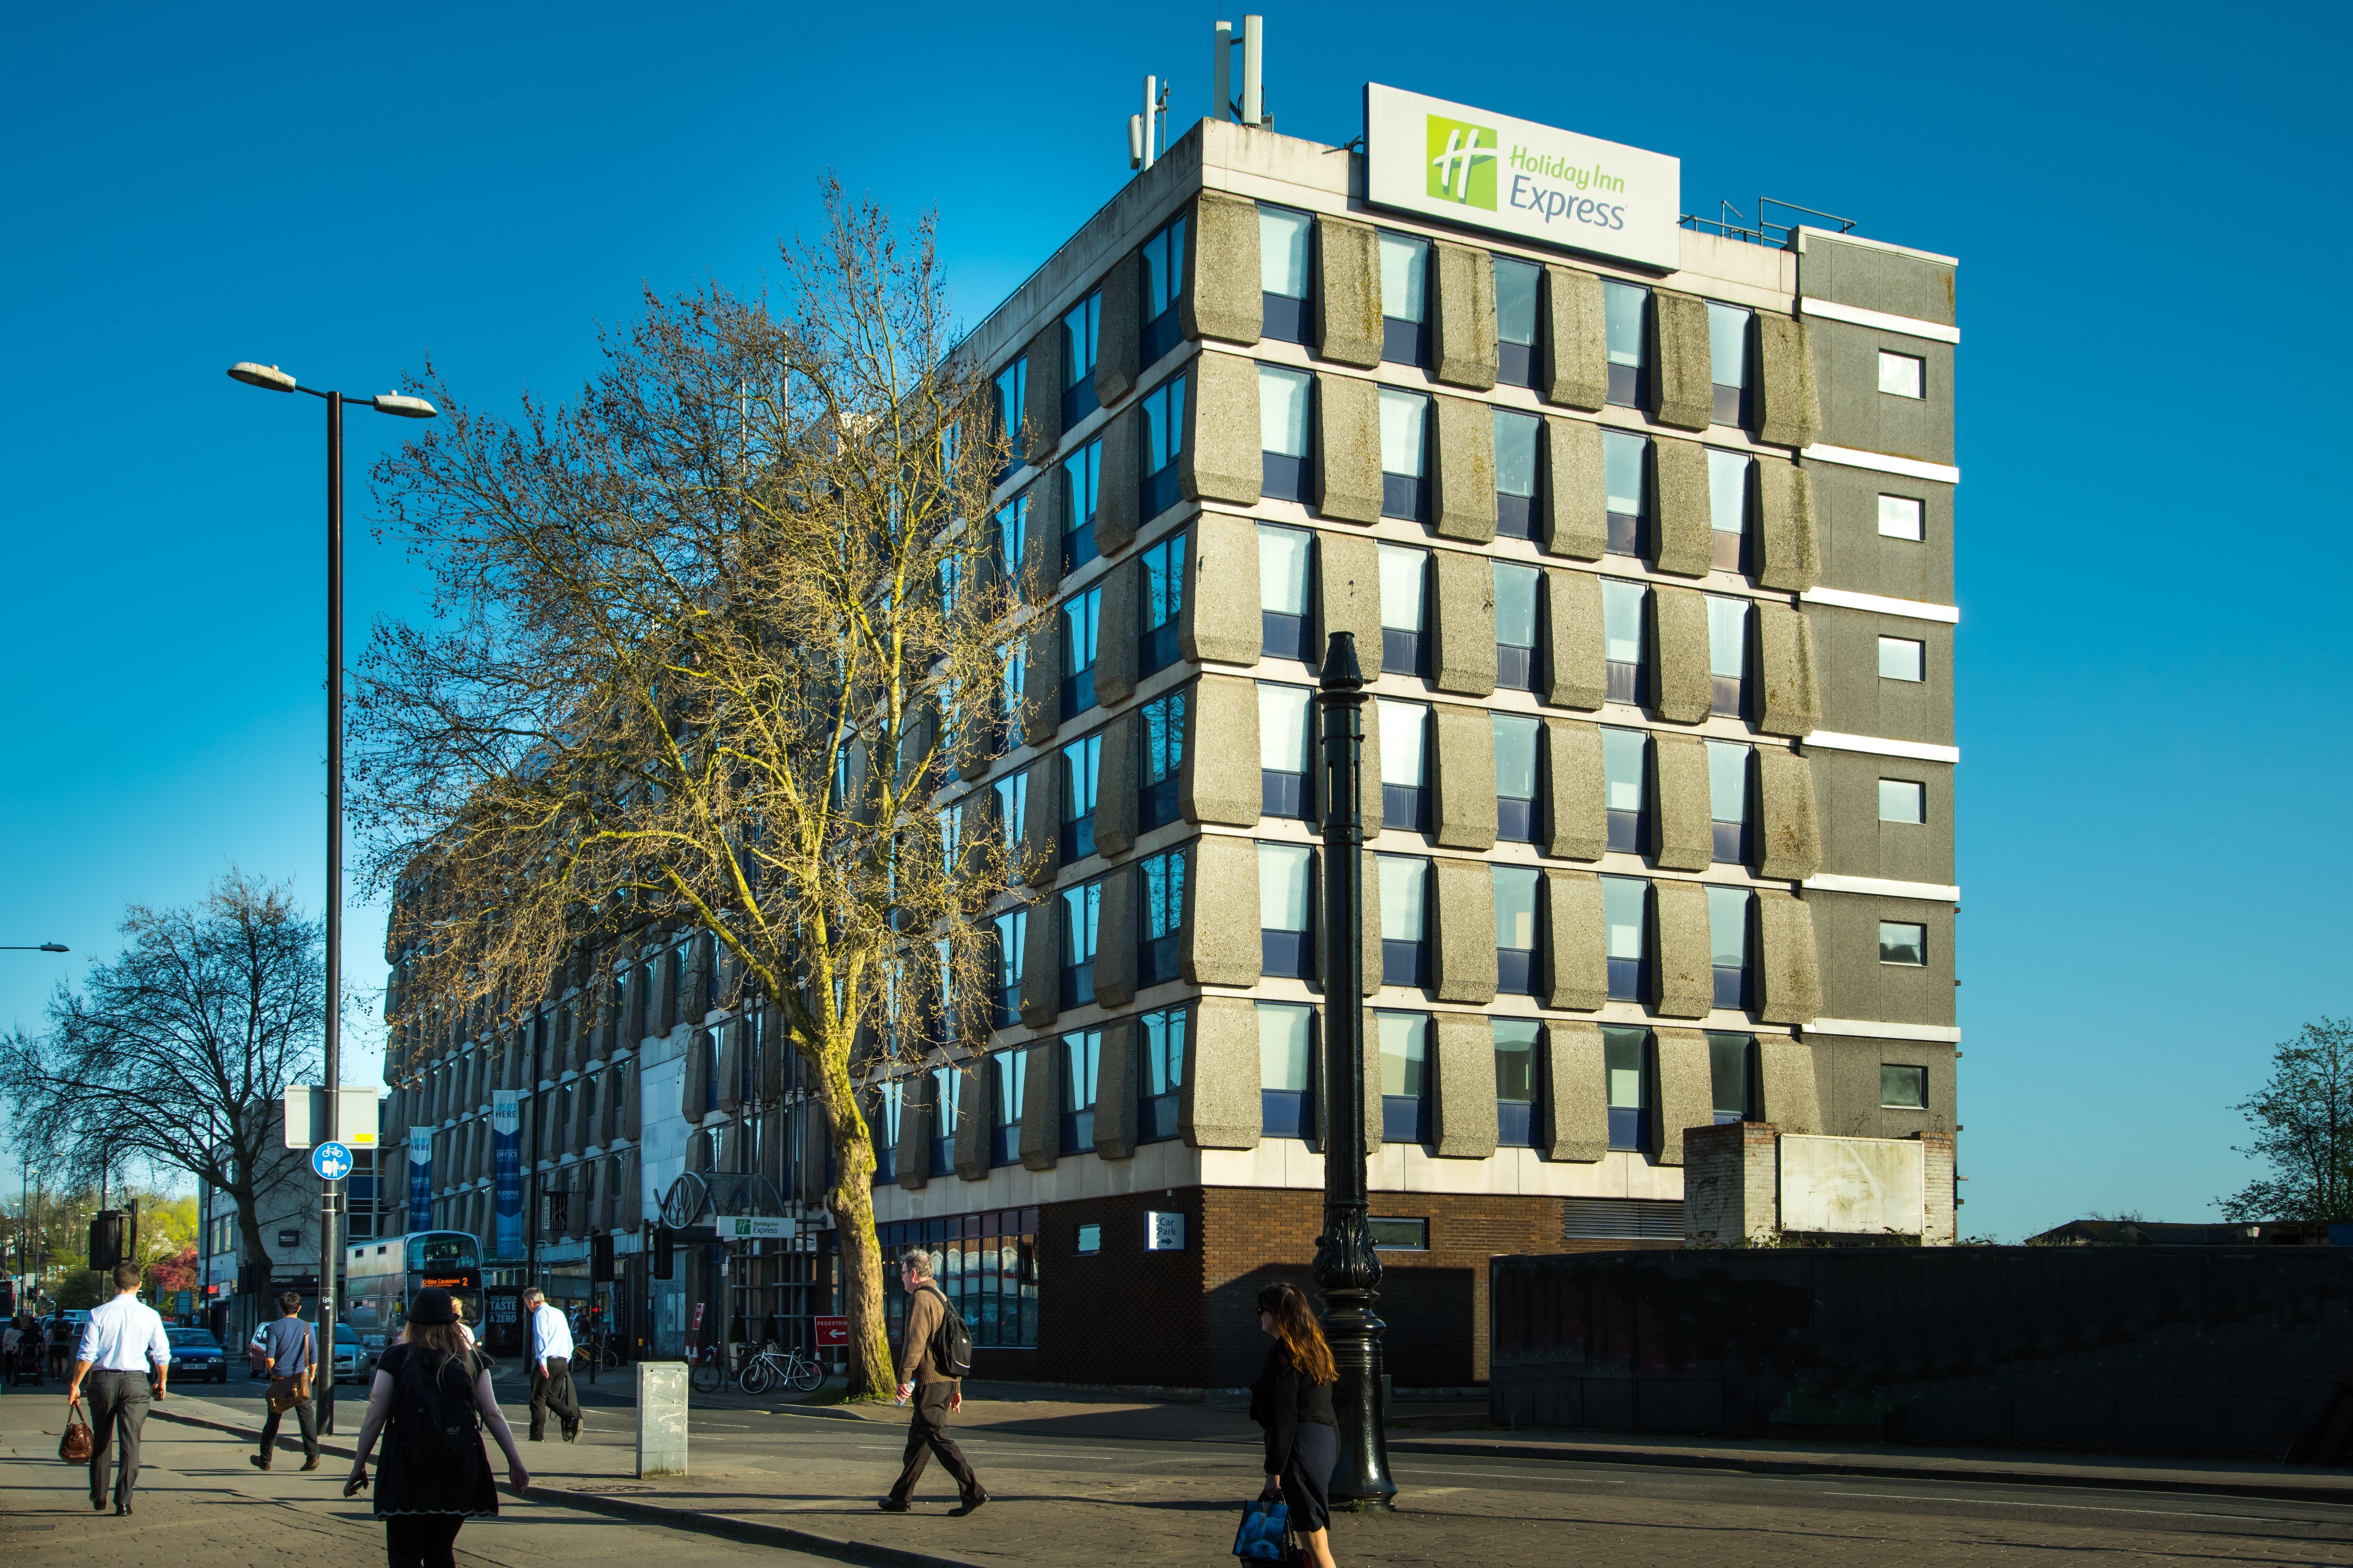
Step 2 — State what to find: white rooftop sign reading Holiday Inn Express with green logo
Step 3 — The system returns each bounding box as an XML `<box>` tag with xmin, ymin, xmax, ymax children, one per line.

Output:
<box><xmin>1365</xmin><ymin>82</ymin><xmax>1682</xmax><ymax>271</ymax></box>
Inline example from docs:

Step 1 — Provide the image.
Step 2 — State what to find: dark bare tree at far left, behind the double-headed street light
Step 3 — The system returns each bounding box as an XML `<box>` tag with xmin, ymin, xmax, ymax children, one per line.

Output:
<box><xmin>0</xmin><ymin>871</ymin><xmax>327</xmax><ymax>1279</ymax></box>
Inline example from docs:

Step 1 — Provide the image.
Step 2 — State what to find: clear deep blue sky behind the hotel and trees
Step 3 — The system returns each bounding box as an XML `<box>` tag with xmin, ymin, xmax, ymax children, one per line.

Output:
<box><xmin>0</xmin><ymin>0</ymin><xmax>2353</xmax><ymax>1238</ymax></box>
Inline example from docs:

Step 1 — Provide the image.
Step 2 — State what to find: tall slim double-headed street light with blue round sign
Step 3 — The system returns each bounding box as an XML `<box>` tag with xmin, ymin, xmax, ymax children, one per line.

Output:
<box><xmin>228</xmin><ymin>360</ymin><xmax>440</xmax><ymax>1432</ymax></box>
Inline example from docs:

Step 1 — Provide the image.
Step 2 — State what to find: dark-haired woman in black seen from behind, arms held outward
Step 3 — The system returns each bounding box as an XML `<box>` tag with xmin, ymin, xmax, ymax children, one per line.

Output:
<box><xmin>344</xmin><ymin>1285</ymin><xmax>532</xmax><ymax>1568</ymax></box>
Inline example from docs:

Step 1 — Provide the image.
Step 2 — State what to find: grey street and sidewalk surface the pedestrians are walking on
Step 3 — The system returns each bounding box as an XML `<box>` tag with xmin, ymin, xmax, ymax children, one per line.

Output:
<box><xmin>0</xmin><ymin>1377</ymin><xmax>2353</xmax><ymax>1568</ymax></box>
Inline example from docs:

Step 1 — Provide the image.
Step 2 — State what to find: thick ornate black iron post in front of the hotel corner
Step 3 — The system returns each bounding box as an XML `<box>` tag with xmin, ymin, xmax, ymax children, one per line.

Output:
<box><xmin>1315</xmin><ymin>631</ymin><xmax>1398</xmax><ymax>1504</ymax></box>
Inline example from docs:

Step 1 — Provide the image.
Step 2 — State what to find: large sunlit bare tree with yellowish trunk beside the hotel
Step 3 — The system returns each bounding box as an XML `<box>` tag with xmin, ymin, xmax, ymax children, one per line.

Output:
<box><xmin>355</xmin><ymin>186</ymin><xmax>1019</xmax><ymax>1391</ymax></box>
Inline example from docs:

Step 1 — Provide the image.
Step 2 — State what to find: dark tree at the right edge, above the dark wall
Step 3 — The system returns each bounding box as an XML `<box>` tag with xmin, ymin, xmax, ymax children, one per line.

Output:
<box><xmin>2221</xmin><ymin>1017</ymin><xmax>2353</xmax><ymax>1222</ymax></box>
